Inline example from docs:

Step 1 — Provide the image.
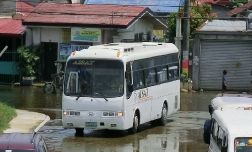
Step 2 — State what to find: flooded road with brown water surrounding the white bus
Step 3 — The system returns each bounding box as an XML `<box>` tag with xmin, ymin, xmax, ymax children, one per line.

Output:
<box><xmin>0</xmin><ymin>86</ymin><xmax>218</xmax><ymax>152</ymax></box>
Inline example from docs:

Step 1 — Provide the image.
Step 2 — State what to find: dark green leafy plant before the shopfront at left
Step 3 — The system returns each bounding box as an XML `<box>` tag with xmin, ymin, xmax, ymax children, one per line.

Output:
<box><xmin>17</xmin><ymin>46</ymin><xmax>41</xmax><ymax>76</ymax></box>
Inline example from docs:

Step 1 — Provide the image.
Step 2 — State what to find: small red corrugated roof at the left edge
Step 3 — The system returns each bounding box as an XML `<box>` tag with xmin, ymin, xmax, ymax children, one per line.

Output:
<box><xmin>0</xmin><ymin>18</ymin><xmax>25</xmax><ymax>35</ymax></box>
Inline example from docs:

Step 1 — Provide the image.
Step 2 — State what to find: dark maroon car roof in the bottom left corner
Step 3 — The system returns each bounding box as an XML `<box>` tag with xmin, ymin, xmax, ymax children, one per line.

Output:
<box><xmin>0</xmin><ymin>132</ymin><xmax>35</xmax><ymax>150</ymax></box>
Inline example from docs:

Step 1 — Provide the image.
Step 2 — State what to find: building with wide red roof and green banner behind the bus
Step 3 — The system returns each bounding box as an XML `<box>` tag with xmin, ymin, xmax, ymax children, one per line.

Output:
<box><xmin>22</xmin><ymin>2</ymin><xmax>167</xmax><ymax>80</ymax></box>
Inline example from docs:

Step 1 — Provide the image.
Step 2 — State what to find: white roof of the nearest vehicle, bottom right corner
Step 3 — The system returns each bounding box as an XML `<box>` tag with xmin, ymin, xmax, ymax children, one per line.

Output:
<box><xmin>213</xmin><ymin>110</ymin><xmax>252</xmax><ymax>137</ymax></box>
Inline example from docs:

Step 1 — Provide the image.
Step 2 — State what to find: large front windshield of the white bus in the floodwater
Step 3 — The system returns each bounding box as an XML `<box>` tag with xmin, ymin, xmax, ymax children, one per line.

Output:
<box><xmin>64</xmin><ymin>59</ymin><xmax>124</xmax><ymax>98</ymax></box>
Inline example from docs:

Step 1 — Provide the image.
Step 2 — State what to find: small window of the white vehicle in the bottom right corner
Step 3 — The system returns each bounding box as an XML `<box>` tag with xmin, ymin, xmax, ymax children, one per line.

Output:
<box><xmin>235</xmin><ymin>137</ymin><xmax>252</xmax><ymax>152</ymax></box>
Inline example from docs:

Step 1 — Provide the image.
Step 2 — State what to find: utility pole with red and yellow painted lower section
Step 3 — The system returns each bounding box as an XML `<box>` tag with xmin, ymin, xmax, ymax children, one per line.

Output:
<box><xmin>182</xmin><ymin>0</ymin><xmax>190</xmax><ymax>76</ymax></box>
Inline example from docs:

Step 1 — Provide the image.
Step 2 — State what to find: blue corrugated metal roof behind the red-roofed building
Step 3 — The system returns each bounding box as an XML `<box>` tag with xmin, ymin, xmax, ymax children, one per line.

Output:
<box><xmin>84</xmin><ymin>0</ymin><xmax>184</xmax><ymax>13</ymax></box>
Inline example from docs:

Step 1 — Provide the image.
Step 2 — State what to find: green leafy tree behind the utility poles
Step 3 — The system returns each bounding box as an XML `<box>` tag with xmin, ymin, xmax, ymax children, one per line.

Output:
<box><xmin>165</xmin><ymin>3</ymin><xmax>217</xmax><ymax>43</ymax></box>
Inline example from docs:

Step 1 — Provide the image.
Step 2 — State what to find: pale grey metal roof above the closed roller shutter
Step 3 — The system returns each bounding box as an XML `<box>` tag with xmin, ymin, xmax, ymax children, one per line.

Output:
<box><xmin>197</xmin><ymin>20</ymin><xmax>246</xmax><ymax>32</ymax></box>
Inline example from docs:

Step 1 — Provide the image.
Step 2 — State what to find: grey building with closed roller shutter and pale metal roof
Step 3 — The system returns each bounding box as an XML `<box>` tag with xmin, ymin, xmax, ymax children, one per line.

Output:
<box><xmin>192</xmin><ymin>20</ymin><xmax>252</xmax><ymax>91</ymax></box>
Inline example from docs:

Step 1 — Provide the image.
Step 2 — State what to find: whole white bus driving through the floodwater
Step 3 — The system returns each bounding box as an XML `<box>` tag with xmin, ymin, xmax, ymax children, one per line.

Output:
<box><xmin>62</xmin><ymin>42</ymin><xmax>180</xmax><ymax>133</ymax></box>
